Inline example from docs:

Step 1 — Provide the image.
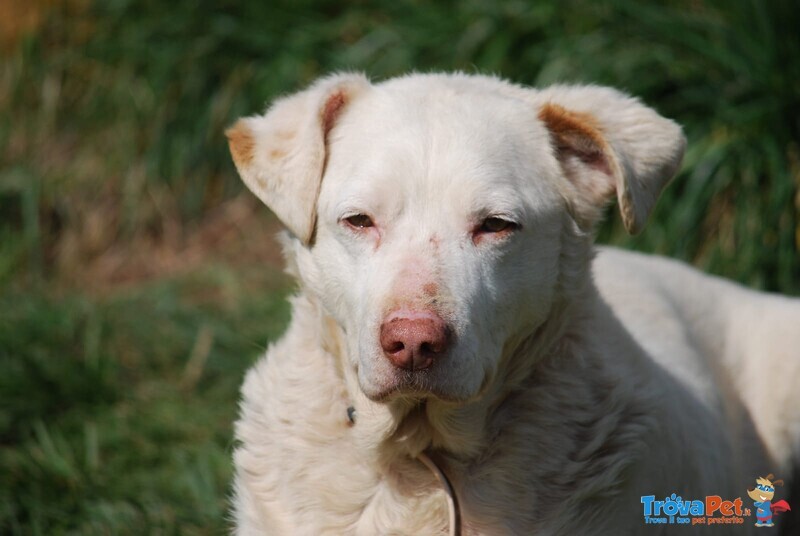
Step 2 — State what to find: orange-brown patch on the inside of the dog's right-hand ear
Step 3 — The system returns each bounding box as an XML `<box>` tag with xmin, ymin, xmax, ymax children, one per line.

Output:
<box><xmin>539</xmin><ymin>103</ymin><xmax>612</xmax><ymax>175</ymax></box>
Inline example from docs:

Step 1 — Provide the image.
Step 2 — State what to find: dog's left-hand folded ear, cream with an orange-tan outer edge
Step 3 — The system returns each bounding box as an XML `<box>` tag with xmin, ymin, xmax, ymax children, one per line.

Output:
<box><xmin>225</xmin><ymin>74</ymin><xmax>370</xmax><ymax>244</ymax></box>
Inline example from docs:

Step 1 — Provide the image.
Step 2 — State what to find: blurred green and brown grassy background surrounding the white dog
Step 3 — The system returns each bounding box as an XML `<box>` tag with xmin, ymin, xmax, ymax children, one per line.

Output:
<box><xmin>0</xmin><ymin>0</ymin><xmax>800</xmax><ymax>534</ymax></box>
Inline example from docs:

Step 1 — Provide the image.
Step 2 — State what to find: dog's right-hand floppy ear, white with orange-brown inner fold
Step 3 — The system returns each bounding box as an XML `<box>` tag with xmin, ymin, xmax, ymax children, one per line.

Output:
<box><xmin>536</xmin><ymin>86</ymin><xmax>686</xmax><ymax>234</ymax></box>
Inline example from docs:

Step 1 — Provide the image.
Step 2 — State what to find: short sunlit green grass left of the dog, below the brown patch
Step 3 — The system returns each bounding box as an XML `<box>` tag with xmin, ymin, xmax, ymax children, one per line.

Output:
<box><xmin>0</xmin><ymin>268</ymin><xmax>287</xmax><ymax>534</ymax></box>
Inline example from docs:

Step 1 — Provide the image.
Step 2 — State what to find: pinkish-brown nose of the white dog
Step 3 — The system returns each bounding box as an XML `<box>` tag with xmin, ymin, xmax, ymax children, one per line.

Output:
<box><xmin>381</xmin><ymin>311</ymin><xmax>450</xmax><ymax>370</ymax></box>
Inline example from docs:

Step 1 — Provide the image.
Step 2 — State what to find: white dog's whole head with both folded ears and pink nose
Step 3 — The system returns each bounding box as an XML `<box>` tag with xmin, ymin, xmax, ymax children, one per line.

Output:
<box><xmin>228</xmin><ymin>75</ymin><xmax>684</xmax><ymax>401</ymax></box>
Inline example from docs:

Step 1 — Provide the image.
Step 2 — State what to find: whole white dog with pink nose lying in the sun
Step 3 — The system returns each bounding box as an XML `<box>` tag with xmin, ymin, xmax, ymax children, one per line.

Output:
<box><xmin>227</xmin><ymin>74</ymin><xmax>800</xmax><ymax>535</ymax></box>
